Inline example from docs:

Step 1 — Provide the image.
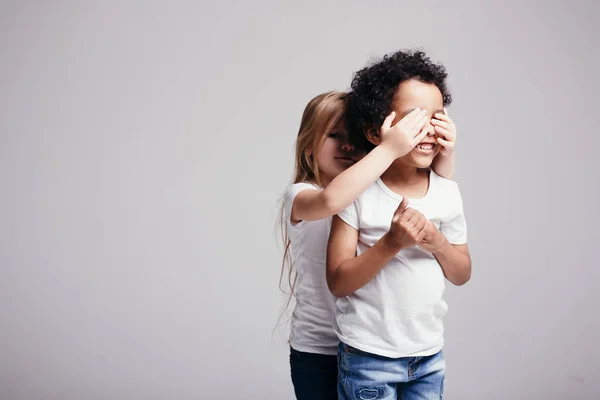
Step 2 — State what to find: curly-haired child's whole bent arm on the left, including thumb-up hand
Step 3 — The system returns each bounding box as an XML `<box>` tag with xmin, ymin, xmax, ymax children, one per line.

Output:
<box><xmin>326</xmin><ymin>197</ymin><xmax>427</xmax><ymax>297</ymax></box>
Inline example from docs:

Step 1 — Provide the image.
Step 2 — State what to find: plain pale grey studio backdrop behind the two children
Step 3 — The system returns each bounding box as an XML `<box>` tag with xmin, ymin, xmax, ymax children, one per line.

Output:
<box><xmin>0</xmin><ymin>0</ymin><xmax>600</xmax><ymax>400</ymax></box>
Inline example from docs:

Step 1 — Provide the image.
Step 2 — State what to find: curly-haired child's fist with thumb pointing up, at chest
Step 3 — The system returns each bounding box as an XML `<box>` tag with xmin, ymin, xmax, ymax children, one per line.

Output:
<box><xmin>388</xmin><ymin>196</ymin><xmax>428</xmax><ymax>251</ymax></box>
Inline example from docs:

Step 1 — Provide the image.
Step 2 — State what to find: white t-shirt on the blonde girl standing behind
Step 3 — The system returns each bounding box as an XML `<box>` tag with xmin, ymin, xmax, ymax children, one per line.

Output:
<box><xmin>283</xmin><ymin>183</ymin><xmax>339</xmax><ymax>355</ymax></box>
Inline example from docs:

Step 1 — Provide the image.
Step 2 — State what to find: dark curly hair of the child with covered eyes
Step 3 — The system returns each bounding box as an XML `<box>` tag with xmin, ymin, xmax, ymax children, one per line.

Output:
<box><xmin>346</xmin><ymin>50</ymin><xmax>452</xmax><ymax>151</ymax></box>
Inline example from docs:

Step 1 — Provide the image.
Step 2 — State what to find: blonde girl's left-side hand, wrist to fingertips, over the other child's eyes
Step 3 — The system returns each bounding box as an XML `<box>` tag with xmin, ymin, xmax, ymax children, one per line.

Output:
<box><xmin>380</xmin><ymin>108</ymin><xmax>429</xmax><ymax>158</ymax></box>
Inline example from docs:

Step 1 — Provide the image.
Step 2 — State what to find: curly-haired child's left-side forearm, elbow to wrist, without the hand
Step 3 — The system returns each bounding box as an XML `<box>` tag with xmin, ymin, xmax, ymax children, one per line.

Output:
<box><xmin>329</xmin><ymin>233</ymin><xmax>400</xmax><ymax>297</ymax></box>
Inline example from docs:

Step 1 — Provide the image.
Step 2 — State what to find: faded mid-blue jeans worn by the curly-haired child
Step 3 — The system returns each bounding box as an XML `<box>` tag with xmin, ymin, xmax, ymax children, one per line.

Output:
<box><xmin>338</xmin><ymin>343</ymin><xmax>446</xmax><ymax>400</ymax></box>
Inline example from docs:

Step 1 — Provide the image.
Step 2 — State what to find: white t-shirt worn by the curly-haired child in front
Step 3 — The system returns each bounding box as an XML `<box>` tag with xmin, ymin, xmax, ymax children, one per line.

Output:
<box><xmin>333</xmin><ymin>171</ymin><xmax>467</xmax><ymax>358</ymax></box>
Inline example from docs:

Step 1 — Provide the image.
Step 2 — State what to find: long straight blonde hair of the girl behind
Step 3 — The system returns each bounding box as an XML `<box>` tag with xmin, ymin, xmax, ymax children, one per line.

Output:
<box><xmin>278</xmin><ymin>91</ymin><xmax>347</xmax><ymax>319</ymax></box>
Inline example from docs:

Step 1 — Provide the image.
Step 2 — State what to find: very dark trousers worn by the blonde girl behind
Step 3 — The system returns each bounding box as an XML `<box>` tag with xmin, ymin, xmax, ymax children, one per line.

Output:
<box><xmin>290</xmin><ymin>347</ymin><xmax>338</xmax><ymax>400</ymax></box>
